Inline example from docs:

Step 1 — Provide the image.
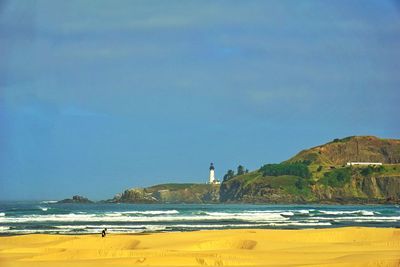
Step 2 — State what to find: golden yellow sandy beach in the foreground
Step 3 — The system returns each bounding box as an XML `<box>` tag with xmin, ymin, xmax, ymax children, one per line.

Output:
<box><xmin>0</xmin><ymin>227</ymin><xmax>400</xmax><ymax>267</ymax></box>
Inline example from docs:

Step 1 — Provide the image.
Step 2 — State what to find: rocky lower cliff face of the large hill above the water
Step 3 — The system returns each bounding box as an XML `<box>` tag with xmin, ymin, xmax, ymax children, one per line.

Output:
<box><xmin>220</xmin><ymin>174</ymin><xmax>400</xmax><ymax>204</ymax></box>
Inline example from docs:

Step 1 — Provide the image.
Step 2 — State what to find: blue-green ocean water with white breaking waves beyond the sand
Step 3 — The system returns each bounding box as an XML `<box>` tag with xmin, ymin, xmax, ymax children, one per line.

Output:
<box><xmin>0</xmin><ymin>201</ymin><xmax>400</xmax><ymax>235</ymax></box>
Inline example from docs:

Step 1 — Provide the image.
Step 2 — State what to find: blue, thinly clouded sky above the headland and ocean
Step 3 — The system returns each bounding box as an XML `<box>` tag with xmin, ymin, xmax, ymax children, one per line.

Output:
<box><xmin>0</xmin><ymin>0</ymin><xmax>400</xmax><ymax>200</ymax></box>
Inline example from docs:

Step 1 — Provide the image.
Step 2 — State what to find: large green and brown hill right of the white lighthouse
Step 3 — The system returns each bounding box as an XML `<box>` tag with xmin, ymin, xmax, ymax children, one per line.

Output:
<box><xmin>220</xmin><ymin>136</ymin><xmax>400</xmax><ymax>203</ymax></box>
